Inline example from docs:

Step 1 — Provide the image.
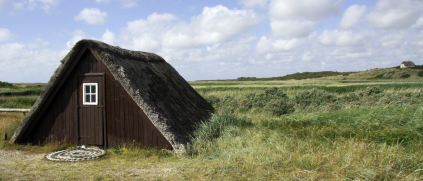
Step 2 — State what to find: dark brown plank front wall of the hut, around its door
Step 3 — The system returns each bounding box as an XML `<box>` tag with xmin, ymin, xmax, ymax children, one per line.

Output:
<box><xmin>24</xmin><ymin>49</ymin><xmax>172</xmax><ymax>149</ymax></box>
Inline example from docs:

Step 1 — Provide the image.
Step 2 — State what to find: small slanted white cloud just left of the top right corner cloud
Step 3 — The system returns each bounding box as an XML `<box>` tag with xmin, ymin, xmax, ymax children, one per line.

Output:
<box><xmin>339</xmin><ymin>5</ymin><xmax>366</xmax><ymax>29</ymax></box>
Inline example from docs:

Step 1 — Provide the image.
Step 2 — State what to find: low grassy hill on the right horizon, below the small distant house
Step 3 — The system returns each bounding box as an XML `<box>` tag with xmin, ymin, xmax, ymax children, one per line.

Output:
<box><xmin>236</xmin><ymin>65</ymin><xmax>423</xmax><ymax>81</ymax></box>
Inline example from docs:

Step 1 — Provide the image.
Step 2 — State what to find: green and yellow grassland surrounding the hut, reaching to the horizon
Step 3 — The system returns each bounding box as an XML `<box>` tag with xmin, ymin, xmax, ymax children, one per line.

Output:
<box><xmin>0</xmin><ymin>68</ymin><xmax>423</xmax><ymax>180</ymax></box>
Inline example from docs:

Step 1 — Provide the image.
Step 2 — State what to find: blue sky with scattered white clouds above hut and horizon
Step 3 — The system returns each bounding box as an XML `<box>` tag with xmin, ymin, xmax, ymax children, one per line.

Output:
<box><xmin>0</xmin><ymin>0</ymin><xmax>423</xmax><ymax>83</ymax></box>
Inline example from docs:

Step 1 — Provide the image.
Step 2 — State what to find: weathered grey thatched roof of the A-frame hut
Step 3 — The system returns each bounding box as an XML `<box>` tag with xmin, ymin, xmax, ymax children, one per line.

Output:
<box><xmin>10</xmin><ymin>40</ymin><xmax>214</xmax><ymax>149</ymax></box>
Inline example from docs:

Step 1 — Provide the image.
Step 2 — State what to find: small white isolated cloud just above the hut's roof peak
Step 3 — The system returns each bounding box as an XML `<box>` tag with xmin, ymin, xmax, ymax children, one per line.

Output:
<box><xmin>74</xmin><ymin>8</ymin><xmax>107</xmax><ymax>25</ymax></box>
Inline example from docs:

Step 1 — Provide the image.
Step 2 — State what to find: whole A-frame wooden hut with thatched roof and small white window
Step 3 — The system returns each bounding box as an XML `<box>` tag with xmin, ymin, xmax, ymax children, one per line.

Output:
<box><xmin>10</xmin><ymin>40</ymin><xmax>213</xmax><ymax>150</ymax></box>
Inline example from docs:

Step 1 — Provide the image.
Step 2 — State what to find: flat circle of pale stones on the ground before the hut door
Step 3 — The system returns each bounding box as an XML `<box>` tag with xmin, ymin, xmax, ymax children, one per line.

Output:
<box><xmin>45</xmin><ymin>145</ymin><xmax>106</xmax><ymax>162</ymax></box>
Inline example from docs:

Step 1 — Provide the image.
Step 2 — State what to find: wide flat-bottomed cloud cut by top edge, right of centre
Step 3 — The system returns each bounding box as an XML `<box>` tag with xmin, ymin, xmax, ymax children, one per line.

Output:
<box><xmin>269</xmin><ymin>0</ymin><xmax>339</xmax><ymax>20</ymax></box>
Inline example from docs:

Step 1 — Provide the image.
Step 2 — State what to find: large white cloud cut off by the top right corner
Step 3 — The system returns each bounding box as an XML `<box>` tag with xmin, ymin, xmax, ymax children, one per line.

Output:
<box><xmin>367</xmin><ymin>0</ymin><xmax>423</xmax><ymax>29</ymax></box>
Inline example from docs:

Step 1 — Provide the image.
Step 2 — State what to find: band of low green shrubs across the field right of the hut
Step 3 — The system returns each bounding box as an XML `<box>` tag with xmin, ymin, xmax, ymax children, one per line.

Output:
<box><xmin>204</xmin><ymin>86</ymin><xmax>423</xmax><ymax>116</ymax></box>
